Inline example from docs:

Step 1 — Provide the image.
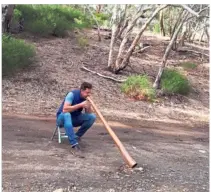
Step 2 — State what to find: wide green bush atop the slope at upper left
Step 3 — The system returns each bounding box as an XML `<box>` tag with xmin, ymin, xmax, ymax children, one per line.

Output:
<box><xmin>15</xmin><ymin>5</ymin><xmax>91</xmax><ymax>37</ymax></box>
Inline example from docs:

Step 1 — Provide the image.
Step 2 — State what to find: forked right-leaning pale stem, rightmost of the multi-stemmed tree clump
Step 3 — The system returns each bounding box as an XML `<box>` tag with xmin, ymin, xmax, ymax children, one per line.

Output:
<box><xmin>114</xmin><ymin>5</ymin><xmax>168</xmax><ymax>73</ymax></box>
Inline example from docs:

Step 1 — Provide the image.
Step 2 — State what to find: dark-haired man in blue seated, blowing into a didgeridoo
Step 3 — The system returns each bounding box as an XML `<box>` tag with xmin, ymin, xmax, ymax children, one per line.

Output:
<box><xmin>56</xmin><ymin>82</ymin><xmax>96</xmax><ymax>156</ymax></box>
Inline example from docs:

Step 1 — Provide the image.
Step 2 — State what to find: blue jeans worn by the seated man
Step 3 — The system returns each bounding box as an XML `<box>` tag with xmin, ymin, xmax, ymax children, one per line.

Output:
<box><xmin>56</xmin><ymin>112</ymin><xmax>96</xmax><ymax>146</ymax></box>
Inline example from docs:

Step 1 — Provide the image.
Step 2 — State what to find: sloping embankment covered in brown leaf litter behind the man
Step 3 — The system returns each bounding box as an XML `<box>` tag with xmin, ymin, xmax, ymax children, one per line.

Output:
<box><xmin>2</xmin><ymin>28</ymin><xmax>209</xmax><ymax>123</ymax></box>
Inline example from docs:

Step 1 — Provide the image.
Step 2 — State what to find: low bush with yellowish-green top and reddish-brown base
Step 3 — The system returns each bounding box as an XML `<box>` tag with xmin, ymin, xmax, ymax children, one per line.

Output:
<box><xmin>121</xmin><ymin>75</ymin><xmax>155</xmax><ymax>101</ymax></box>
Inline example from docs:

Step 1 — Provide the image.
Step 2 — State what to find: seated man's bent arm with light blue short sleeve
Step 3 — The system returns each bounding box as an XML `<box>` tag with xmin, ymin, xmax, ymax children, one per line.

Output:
<box><xmin>63</xmin><ymin>92</ymin><xmax>84</xmax><ymax>113</ymax></box>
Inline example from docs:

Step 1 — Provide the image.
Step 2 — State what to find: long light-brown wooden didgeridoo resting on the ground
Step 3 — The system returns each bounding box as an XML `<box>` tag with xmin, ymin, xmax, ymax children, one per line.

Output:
<box><xmin>87</xmin><ymin>97</ymin><xmax>137</xmax><ymax>168</ymax></box>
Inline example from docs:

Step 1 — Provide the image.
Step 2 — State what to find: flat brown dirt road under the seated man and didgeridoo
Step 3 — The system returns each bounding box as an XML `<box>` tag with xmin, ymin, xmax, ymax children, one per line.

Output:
<box><xmin>2</xmin><ymin>116</ymin><xmax>209</xmax><ymax>192</ymax></box>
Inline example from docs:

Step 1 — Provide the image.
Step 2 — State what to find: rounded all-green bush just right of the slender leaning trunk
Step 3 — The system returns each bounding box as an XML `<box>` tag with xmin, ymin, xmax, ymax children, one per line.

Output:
<box><xmin>161</xmin><ymin>69</ymin><xmax>190</xmax><ymax>95</ymax></box>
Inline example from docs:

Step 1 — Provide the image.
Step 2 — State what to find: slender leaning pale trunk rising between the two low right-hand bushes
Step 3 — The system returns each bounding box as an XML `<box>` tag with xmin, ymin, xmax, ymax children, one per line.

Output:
<box><xmin>153</xmin><ymin>12</ymin><xmax>188</xmax><ymax>89</ymax></box>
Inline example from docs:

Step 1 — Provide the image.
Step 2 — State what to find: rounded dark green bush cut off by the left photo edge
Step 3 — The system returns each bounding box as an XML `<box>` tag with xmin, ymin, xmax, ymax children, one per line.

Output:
<box><xmin>2</xmin><ymin>35</ymin><xmax>35</xmax><ymax>75</ymax></box>
